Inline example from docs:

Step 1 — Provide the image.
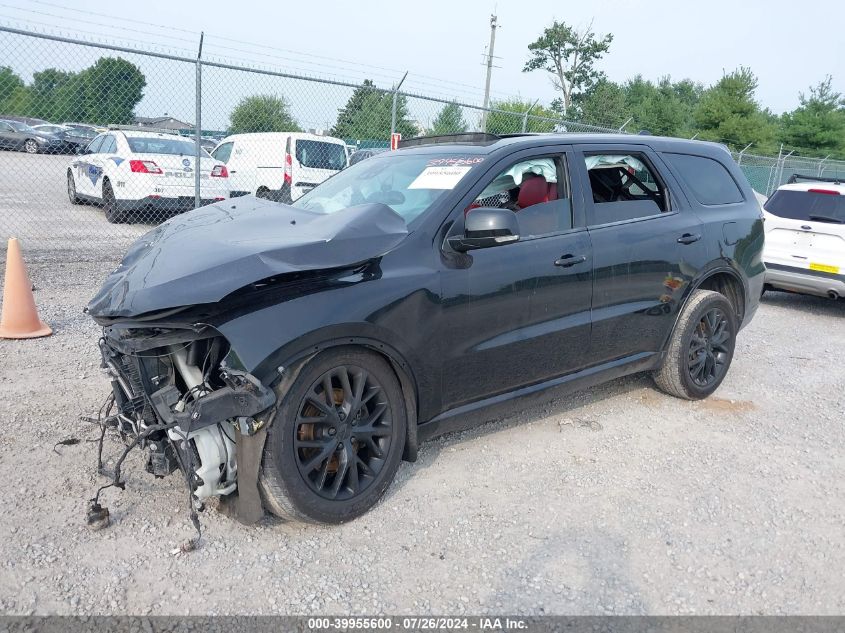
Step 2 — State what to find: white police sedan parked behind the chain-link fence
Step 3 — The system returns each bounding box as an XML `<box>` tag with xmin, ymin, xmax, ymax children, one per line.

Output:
<box><xmin>67</xmin><ymin>129</ymin><xmax>229</xmax><ymax>223</ymax></box>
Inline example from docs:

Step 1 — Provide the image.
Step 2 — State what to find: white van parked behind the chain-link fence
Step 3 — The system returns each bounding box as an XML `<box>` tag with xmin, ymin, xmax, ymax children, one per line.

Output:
<box><xmin>211</xmin><ymin>132</ymin><xmax>349</xmax><ymax>203</ymax></box>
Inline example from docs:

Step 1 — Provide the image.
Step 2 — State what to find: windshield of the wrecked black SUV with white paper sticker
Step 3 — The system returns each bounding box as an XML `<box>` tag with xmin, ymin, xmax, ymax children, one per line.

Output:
<box><xmin>293</xmin><ymin>153</ymin><xmax>484</xmax><ymax>224</ymax></box>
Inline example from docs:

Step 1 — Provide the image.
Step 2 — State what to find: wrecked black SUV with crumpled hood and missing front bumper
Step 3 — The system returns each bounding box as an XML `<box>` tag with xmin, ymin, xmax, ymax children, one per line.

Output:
<box><xmin>88</xmin><ymin>134</ymin><xmax>764</xmax><ymax>523</ymax></box>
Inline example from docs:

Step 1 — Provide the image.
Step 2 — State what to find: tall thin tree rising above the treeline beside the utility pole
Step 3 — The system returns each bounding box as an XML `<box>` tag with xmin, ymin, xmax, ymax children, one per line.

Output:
<box><xmin>522</xmin><ymin>20</ymin><xmax>613</xmax><ymax>116</ymax></box>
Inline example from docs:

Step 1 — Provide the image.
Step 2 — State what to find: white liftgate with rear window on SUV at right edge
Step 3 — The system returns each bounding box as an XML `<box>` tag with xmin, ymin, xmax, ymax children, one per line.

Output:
<box><xmin>763</xmin><ymin>183</ymin><xmax>845</xmax><ymax>274</ymax></box>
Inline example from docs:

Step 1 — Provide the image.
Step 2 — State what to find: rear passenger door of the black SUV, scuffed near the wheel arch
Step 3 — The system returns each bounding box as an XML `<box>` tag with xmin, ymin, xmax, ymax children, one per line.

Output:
<box><xmin>576</xmin><ymin>144</ymin><xmax>706</xmax><ymax>364</ymax></box>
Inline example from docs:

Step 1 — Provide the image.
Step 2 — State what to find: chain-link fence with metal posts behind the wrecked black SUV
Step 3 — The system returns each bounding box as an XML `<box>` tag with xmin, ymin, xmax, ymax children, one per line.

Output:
<box><xmin>0</xmin><ymin>27</ymin><xmax>845</xmax><ymax>259</ymax></box>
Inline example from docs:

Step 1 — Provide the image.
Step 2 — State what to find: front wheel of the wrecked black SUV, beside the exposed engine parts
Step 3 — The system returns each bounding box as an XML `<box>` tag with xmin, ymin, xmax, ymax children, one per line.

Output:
<box><xmin>259</xmin><ymin>347</ymin><xmax>407</xmax><ymax>523</ymax></box>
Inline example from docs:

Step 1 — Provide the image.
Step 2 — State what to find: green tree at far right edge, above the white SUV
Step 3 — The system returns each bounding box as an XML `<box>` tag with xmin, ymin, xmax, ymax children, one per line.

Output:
<box><xmin>781</xmin><ymin>75</ymin><xmax>845</xmax><ymax>156</ymax></box>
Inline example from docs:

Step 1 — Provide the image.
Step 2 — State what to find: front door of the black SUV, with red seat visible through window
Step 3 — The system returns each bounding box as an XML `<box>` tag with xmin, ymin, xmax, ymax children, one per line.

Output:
<box><xmin>441</xmin><ymin>147</ymin><xmax>592</xmax><ymax>410</ymax></box>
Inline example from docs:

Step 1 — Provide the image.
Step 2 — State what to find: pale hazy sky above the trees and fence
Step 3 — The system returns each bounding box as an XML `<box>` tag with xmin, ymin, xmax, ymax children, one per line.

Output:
<box><xmin>0</xmin><ymin>0</ymin><xmax>845</xmax><ymax>127</ymax></box>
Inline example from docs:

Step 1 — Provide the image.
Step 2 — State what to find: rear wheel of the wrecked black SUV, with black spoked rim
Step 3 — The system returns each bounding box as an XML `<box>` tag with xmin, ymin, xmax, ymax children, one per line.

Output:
<box><xmin>654</xmin><ymin>290</ymin><xmax>737</xmax><ymax>400</ymax></box>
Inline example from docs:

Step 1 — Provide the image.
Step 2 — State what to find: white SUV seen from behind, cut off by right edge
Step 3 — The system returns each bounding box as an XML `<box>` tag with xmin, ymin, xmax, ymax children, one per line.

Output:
<box><xmin>763</xmin><ymin>174</ymin><xmax>845</xmax><ymax>299</ymax></box>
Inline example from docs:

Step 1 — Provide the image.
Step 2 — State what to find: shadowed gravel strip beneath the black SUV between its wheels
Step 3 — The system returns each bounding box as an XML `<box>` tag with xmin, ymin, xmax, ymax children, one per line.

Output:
<box><xmin>384</xmin><ymin>373</ymin><xmax>654</xmax><ymax>500</ymax></box>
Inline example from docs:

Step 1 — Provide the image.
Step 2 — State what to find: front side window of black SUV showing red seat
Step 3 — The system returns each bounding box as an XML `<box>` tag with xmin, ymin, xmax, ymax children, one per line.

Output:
<box><xmin>467</xmin><ymin>156</ymin><xmax>572</xmax><ymax>237</ymax></box>
